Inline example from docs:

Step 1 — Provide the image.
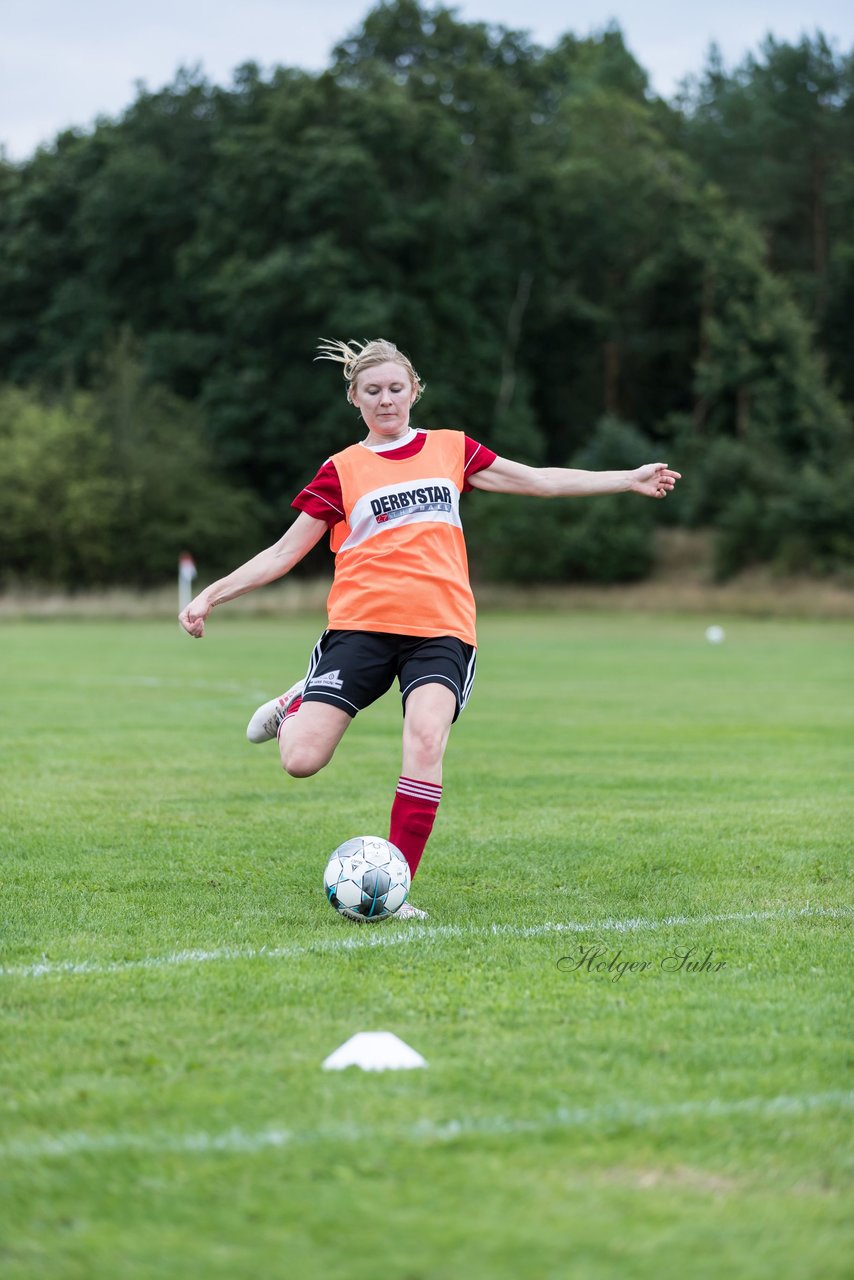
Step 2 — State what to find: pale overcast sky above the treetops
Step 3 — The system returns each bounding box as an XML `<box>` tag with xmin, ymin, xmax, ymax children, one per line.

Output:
<box><xmin>0</xmin><ymin>0</ymin><xmax>854</xmax><ymax>160</ymax></box>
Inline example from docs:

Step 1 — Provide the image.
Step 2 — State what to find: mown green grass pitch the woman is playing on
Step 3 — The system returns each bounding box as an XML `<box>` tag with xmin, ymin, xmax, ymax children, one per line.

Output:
<box><xmin>0</xmin><ymin>613</ymin><xmax>854</xmax><ymax>1280</ymax></box>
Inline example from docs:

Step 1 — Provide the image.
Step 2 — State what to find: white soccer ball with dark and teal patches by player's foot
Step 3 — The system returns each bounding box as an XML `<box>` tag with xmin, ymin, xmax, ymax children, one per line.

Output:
<box><xmin>323</xmin><ymin>836</ymin><xmax>410</xmax><ymax>922</ymax></box>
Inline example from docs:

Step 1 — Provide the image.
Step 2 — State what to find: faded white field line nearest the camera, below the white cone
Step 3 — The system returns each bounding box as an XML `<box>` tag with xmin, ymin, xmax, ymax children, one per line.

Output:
<box><xmin>0</xmin><ymin>1091</ymin><xmax>854</xmax><ymax>1162</ymax></box>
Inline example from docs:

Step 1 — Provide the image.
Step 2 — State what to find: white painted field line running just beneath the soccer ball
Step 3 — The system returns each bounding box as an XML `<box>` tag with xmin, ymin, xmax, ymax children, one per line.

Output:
<box><xmin>0</xmin><ymin>905</ymin><xmax>854</xmax><ymax>978</ymax></box>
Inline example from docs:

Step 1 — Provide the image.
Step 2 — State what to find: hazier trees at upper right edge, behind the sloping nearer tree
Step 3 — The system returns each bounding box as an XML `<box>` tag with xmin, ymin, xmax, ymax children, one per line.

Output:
<box><xmin>680</xmin><ymin>35</ymin><xmax>854</xmax><ymax>403</ymax></box>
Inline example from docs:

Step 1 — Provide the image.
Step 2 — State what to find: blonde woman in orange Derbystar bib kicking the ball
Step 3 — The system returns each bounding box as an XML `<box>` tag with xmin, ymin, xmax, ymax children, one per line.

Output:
<box><xmin>181</xmin><ymin>339</ymin><xmax>681</xmax><ymax>918</ymax></box>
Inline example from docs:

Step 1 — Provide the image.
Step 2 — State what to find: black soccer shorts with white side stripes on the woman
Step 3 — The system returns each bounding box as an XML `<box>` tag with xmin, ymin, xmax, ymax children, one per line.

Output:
<box><xmin>302</xmin><ymin>631</ymin><xmax>478</xmax><ymax>721</ymax></box>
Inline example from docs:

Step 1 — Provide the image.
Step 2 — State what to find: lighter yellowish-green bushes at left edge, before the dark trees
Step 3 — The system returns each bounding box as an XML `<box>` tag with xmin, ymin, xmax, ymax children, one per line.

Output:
<box><xmin>0</xmin><ymin>364</ymin><xmax>261</xmax><ymax>589</ymax></box>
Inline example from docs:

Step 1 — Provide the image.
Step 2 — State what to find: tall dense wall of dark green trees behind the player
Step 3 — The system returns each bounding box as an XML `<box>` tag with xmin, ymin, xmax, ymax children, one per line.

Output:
<box><xmin>0</xmin><ymin>0</ymin><xmax>854</xmax><ymax>584</ymax></box>
